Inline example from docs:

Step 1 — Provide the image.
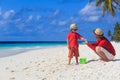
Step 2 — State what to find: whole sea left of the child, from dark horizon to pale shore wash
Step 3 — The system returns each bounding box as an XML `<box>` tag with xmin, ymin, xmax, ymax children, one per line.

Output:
<box><xmin>0</xmin><ymin>41</ymin><xmax>66</xmax><ymax>58</ymax></box>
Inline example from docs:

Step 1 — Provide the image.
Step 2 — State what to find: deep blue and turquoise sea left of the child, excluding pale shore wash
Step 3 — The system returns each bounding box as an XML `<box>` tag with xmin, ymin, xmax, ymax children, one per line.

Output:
<box><xmin>0</xmin><ymin>41</ymin><xmax>66</xmax><ymax>49</ymax></box>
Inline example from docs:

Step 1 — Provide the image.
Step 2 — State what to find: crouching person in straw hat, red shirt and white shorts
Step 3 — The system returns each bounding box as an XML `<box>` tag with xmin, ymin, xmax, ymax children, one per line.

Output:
<box><xmin>85</xmin><ymin>28</ymin><xmax>116</xmax><ymax>61</ymax></box>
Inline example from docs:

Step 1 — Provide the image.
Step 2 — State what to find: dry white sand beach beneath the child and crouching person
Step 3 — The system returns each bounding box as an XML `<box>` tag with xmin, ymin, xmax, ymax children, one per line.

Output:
<box><xmin>0</xmin><ymin>42</ymin><xmax>120</xmax><ymax>80</ymax></box>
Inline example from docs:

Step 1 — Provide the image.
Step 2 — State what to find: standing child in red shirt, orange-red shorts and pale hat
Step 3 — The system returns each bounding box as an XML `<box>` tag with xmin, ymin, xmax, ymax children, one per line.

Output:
<box><xmin>67</xmin><ymin>24</ymin><xmax>86</xmax><ymax>65</ymax></box>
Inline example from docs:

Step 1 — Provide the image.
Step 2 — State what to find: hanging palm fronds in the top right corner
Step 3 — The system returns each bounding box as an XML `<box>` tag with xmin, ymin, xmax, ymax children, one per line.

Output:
<box><xmin>90</xmin><ymin>0</ymin><xmax>120</xmax><ymax>16</ymax></box>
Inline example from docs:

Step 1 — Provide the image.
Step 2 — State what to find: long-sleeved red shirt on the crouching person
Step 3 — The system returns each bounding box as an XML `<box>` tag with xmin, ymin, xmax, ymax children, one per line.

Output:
<box><xmin>87</xmin><ymin>37</ymin><xmax>116</xmax><ymax>56</ymax></box>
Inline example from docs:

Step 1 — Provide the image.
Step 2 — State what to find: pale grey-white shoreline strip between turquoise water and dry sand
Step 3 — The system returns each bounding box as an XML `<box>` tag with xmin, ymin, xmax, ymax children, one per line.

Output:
<box><xmin>0</xmin><ymin>45</ymin><xmax>66</xmax><ymax>58</ymax></box>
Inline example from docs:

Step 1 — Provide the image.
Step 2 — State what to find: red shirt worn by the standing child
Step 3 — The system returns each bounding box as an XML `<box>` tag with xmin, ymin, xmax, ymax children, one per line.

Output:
<box><xmin>67</xmin><ymin>32</ymin><xmax>82</xmax><ymax>48</ymax></box>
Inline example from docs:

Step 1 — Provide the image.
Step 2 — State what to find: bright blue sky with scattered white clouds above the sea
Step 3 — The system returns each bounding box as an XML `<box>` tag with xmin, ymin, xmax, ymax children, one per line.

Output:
<box><xmin>0</xmin><ymin>0</ymin><xmax>120</xmax><ymax>41</ymax></box>
